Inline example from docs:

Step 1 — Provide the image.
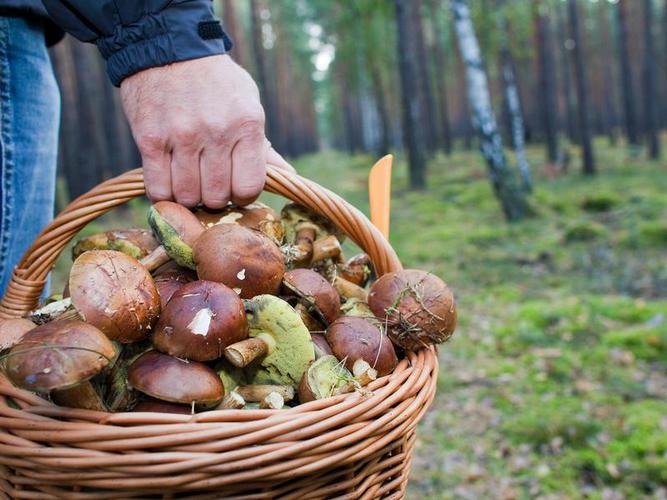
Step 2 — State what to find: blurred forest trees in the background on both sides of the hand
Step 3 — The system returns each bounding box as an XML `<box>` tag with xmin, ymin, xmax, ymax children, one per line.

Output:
<box><xmin>53</xmin><ymin>0</ymin><xmax>667</xmax><ymax>220</ymax></box>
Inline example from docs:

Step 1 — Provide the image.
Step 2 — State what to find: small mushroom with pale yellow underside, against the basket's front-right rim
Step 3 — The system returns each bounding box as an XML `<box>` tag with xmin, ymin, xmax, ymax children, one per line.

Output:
<box><xmin>299</xmin><ymin>356</ymin><xmax>352</xmax><ymax>403</ymax></box>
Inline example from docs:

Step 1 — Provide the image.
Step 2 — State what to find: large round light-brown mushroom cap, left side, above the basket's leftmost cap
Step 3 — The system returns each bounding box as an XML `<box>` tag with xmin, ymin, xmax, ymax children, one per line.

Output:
<box><xmin>69</xmin><ymin>250</ymin><xmax>160</xmax><ymax>343</ymax></box>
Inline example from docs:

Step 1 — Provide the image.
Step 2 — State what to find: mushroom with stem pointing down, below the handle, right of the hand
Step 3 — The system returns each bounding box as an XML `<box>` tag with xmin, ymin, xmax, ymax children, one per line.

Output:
<box><xmin>280</xmin><ymin>203</ymin><xmax>345</xmax><ymax>267</ymax></box>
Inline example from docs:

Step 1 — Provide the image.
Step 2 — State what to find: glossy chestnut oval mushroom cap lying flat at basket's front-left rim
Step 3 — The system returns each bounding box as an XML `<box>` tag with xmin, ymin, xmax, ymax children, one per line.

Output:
<box><xmin>127</xmin><ymin>351</ymin><xmax>225</xmax><ymax>408</ymax></box>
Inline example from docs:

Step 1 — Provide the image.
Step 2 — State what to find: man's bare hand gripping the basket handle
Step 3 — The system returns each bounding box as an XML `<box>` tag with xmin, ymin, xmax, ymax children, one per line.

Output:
<box><xmin>120</xmin><ymin>55</ymin><xmax>291</xmax><ymax>208</ymax></box>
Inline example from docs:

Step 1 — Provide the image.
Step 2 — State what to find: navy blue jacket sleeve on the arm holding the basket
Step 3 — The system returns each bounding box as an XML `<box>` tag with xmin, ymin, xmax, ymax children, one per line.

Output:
<box><xmin>43</xmin><ymin>0</ymin><xmax>232</xmax><ymax>86</ymax></box>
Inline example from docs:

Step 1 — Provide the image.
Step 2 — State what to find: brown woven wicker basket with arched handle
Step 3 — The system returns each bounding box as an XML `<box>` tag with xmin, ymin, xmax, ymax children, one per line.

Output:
<box><xmin>0</xmin><ymin>167</ymin><xmax>438</xmax><ymax>499</ymax></box>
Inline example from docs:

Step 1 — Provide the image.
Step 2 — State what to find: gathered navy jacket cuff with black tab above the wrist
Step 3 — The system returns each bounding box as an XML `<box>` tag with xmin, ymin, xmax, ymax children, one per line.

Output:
<box><xmin>96</xmin><ymin>0</ymin><xmax>232</xmax><ymax>87</ymax></box>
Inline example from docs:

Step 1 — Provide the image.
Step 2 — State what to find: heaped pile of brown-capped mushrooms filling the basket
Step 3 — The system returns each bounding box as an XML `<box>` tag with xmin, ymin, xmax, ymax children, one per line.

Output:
<box><xmin>0</xmin><ymin>201</ymin><xmax>456</xmax><ymax>414</ymax></box>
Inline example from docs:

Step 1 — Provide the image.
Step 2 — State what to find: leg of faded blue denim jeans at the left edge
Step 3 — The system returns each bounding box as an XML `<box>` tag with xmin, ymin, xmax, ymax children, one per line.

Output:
<box><xmin>0</xmin><ymin>16</ymin><xmax>60</xmax><ymax>293</ymax></box>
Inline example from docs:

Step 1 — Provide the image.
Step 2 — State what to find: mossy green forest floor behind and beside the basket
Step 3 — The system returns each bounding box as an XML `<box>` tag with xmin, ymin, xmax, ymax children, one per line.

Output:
<box><xmin>55</xmin><ymin>141</ymin><xmax>667</xmax><ymax>500</ymax></box>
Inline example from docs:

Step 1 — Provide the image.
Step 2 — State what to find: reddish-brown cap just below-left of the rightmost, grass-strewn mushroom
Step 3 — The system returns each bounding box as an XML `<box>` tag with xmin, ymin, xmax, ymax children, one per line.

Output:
<box><xmin>326</xmin><ymin>316</ymin><xmax>398</xmax><ymax>376</ymax></box>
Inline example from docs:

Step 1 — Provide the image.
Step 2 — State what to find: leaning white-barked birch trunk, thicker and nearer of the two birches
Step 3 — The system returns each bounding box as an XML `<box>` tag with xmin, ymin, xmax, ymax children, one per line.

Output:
<box><xmin>450</xmin><ymin>0</ymin><xmax>528</xmax><ymax>221</ymax></box>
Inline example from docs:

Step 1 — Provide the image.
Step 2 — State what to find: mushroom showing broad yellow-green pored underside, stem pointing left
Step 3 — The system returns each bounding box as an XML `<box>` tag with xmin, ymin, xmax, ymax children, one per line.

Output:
<box><xmin>225</xmin><ymin>295</ymin><xmax>315</xmax><ymax>386</ymax></box>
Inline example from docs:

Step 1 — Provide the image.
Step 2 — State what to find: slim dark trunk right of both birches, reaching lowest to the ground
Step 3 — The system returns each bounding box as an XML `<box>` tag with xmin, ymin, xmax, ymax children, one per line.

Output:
<box><xmin>568</xmin><ymin>0</ymin><xmax>595</xmax><ymax>175</ymax></box>
